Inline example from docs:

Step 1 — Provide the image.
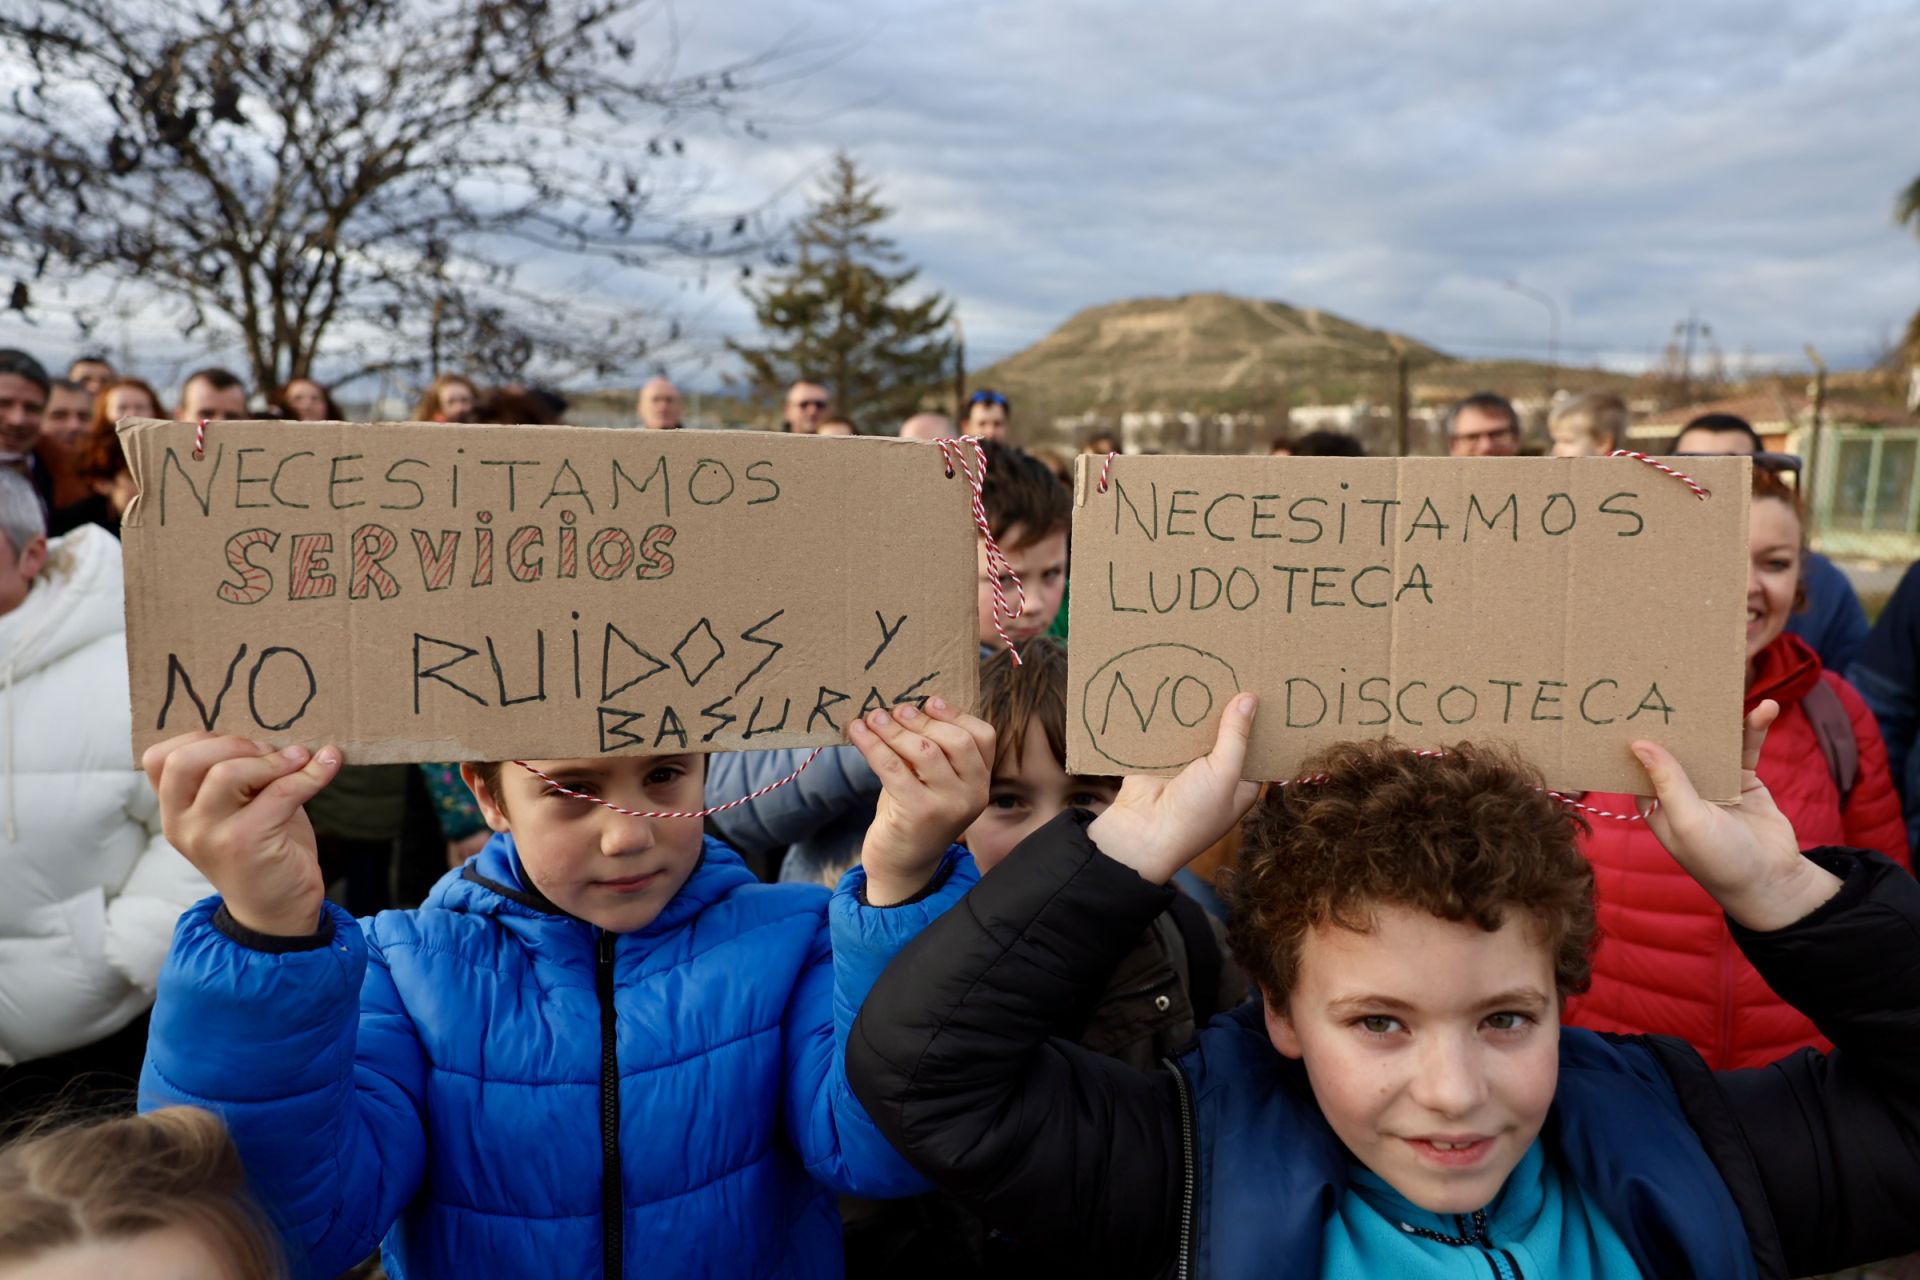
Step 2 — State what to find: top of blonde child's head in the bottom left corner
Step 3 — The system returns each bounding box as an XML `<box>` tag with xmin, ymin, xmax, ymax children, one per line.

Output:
<box><xmin>0</xmin><ymin>1107</ymin><xmax>286</xmax><ymax>1280</ymax></box>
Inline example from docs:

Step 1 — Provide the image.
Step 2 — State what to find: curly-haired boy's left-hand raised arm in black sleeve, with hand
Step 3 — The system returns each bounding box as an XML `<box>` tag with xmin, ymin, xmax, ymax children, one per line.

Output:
<box><xmin>847</xmin><ymin>704</ymin><xmax>1252</xmax><ymax>1276</ymax></box>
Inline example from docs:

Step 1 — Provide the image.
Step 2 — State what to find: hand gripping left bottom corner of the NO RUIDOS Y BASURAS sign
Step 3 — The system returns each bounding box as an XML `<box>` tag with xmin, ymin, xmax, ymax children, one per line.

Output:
<box><xmin>140</xmin><ymin>733</ymin><xmax>340</xmax><ymax>936</ymax></box>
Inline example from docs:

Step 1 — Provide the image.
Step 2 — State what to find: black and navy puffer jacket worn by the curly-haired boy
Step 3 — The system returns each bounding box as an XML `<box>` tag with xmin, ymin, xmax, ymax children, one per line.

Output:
<box><xmin>847</xmin><ymin>814</ymin><xmax>1920</xmax><ymax>1280</ymax></box>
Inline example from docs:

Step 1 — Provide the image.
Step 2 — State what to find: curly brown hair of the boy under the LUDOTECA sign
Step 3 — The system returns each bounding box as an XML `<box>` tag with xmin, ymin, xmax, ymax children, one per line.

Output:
<box><xmin>1219</xmin><ymin>739</ymin><xmax>1597</xmax><ymax>1006</ymax></box>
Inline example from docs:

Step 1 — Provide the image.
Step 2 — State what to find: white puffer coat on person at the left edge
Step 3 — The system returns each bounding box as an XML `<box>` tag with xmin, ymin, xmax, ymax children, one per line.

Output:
<box><xmin>0</xmin><ymin>524</ymin><xmax>211</xmax><ymax>1065</ymax></box>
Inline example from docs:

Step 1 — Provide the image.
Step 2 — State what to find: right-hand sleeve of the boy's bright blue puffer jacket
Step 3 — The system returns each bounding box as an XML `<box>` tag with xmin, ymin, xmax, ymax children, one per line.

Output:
<box><xmin>785</xmin><ymin>844</ymin><xmax>979</xmax><ymax>1199</ymax></box>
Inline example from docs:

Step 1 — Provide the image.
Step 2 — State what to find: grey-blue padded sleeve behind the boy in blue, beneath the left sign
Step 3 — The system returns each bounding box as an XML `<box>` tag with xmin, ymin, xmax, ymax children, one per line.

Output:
<box><xmin>707</xmin><ymin>747</ymin><xmax>879</xmax><ymax>858</ymax></box>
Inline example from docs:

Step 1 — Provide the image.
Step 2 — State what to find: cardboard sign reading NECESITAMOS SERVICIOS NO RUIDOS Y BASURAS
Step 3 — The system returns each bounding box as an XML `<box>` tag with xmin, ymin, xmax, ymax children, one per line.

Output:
<box><xmin>121</xmin><ymin>422</ymin><xmax>979</xmax><ymax>764</ymax></box>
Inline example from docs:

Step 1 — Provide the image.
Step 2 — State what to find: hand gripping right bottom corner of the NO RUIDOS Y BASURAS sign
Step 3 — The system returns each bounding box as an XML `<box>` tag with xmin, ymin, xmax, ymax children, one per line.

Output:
<box><xmin>847</xmin><ymin>699</ymin><xmax>993</xmax><ymax>906</ymax></box>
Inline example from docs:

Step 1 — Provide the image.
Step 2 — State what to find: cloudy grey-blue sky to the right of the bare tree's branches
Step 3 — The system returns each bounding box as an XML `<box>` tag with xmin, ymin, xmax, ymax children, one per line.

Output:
<box><xmin>652</xmin><ymin>0</ymin><xmax>1920</xmax><ymax>379</ymax></box>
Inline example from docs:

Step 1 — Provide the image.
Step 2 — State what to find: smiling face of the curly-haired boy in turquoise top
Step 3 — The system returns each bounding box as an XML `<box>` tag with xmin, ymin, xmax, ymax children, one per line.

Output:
<box><xmin>1267</xmin><ymin>906</ymin><xmax>1559</xmax><ymax>1213</ymax></box>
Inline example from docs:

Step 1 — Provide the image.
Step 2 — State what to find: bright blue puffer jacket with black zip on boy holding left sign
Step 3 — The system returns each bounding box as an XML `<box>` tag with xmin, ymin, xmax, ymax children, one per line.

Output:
<box><xmin>140</xmin><ymin>835</ymin><xmax>977</xmax><ymax>1280</ymax></box>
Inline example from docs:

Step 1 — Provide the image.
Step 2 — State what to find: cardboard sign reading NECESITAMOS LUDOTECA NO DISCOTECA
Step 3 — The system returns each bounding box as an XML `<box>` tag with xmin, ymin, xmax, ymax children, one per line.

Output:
<box><xmin>1068</xmin><ymin>457</ymin><xmax>1753</xmax><ymax>802</ymax></box>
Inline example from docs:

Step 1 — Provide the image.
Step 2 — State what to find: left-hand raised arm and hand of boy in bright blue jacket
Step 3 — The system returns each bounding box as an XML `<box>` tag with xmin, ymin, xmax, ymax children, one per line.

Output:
<box><xmin>140</xmin><ymin>733</ymin><xmax>426</xmax><ymax>1278</ymax></box>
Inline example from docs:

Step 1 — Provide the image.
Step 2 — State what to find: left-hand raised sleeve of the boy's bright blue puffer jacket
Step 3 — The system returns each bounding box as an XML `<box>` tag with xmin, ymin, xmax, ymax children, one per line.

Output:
<box><xmin>140</xmin><ymin>898</ymin><xmax>426</xmax><ymax>1278</ymax></box>
